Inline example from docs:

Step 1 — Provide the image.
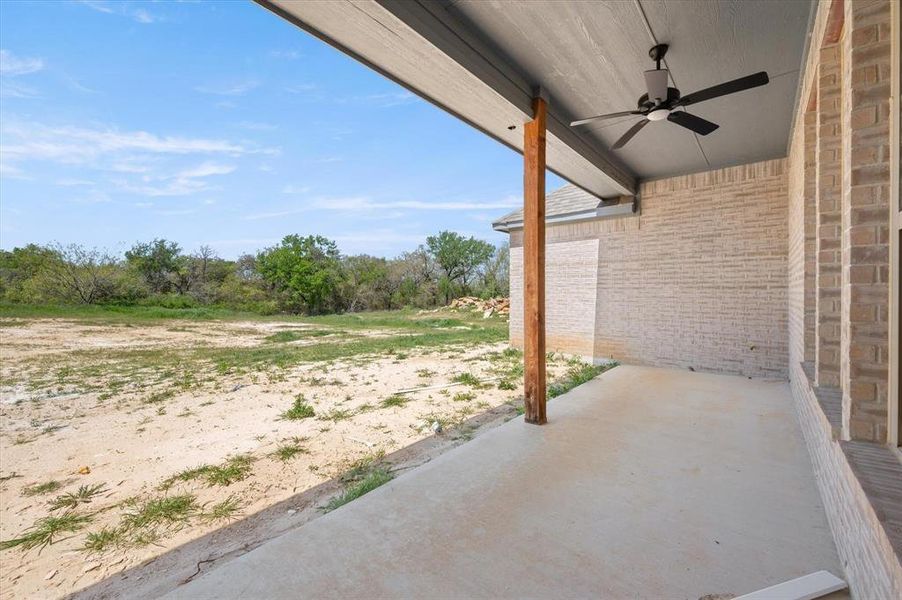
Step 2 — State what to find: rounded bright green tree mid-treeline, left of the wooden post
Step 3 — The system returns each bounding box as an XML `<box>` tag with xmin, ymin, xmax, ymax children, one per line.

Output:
<box><xmin>257</xmin><ymin>235</ymin><xmax>341</xmax><ymax>314</ymax></box>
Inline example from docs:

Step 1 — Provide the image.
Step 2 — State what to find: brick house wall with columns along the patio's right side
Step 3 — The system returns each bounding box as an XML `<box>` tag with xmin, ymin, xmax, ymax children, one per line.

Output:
<box><xmin>787</xmin><ymin>0</ymin><xmax>902</xmax><ymax>599</ymax></box>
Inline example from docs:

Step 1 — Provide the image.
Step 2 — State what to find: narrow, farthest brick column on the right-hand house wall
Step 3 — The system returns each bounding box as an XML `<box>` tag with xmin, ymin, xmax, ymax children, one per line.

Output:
<box><xmin>802</xmin><ymin>107</ymin><xmax>817</xmax><ymax>364</ymax></box>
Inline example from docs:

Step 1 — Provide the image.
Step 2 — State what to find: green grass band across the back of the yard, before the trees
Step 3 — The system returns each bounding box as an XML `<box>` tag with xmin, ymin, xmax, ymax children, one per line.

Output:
<box><xmin>0</xmin><ymin>303</ymin><xmax>508</xmax><ymax>390</ymax></box>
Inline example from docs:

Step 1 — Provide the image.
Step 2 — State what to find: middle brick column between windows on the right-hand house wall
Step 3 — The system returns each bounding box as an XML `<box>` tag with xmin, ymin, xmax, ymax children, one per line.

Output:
<box><xmin>815</xmin><ymin>44</ymin><xmax>842</xmax><ymax>387</ymax></box>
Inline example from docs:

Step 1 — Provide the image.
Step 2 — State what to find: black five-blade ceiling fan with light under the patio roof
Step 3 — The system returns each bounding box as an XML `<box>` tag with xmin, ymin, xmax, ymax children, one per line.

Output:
<box><xmin>570</xmin><ymin>44</ymin><xmax>770</xmax><ymax>150</ymax></box>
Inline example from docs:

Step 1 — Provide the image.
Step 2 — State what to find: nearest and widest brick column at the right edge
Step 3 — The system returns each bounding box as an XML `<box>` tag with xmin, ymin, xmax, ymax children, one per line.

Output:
<box><xmin>841</xmin><ymin>0</ymin><xmax>890</xmax><ymax>443</ymax></box>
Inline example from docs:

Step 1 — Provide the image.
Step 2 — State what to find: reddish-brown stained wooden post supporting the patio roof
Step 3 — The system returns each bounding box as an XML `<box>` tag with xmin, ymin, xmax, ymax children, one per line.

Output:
<box><xmin>523</xmin><ymin>98</ymin><xmax>546</xmax><ymax>425</ymax></box>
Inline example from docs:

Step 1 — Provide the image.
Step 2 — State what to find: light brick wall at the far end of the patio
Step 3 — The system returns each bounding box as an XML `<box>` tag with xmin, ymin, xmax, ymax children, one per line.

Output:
<box><xmin>511</xmin><ymin>160</ymin><xmax>788</xmax><ymax>377</ymax></box>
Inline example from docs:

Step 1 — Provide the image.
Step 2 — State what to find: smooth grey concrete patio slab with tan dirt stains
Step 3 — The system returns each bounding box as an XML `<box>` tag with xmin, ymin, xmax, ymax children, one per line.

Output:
<box><xmin>169</xmin><ymin>366</ymin><xmax>843</xmax><ymax>599</ymax></box>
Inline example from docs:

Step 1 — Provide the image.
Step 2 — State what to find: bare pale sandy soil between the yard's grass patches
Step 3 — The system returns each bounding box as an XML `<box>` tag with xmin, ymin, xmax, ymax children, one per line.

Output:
<box><xmin>0</xmin><ymin>319</ymin><xmax>562</xmax><ymax>599</ymax></box>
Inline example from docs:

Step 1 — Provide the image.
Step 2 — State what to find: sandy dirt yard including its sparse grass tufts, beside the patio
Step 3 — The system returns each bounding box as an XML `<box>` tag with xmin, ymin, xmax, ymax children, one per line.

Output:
<box><xmin>0</xmin><ymin>312</ymin><xmax>566</xmax><ymax>599</ymax></box>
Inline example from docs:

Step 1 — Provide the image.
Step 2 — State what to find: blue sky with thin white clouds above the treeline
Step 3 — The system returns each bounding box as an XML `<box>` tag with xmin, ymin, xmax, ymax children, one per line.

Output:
<box><xmin>0</xmin><ymin>0</ymin><xmax>563</xmax><ymax>258</ymax></box>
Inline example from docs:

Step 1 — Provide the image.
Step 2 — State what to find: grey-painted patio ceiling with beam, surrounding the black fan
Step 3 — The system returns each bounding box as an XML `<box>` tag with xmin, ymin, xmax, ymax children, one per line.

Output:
<box><xmin>257</xmin><ymin>0</ymin><xmax>812</xmax><ymax>197</ymax></box>
